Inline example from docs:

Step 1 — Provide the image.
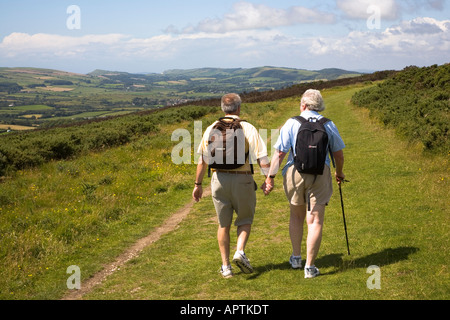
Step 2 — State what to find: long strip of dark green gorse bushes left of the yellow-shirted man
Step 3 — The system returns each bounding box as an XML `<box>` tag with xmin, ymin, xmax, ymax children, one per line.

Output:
<box><xmin>0</xmin><ymin>107</ymin><xmax>217</xmax><ymax>176</ymax></box>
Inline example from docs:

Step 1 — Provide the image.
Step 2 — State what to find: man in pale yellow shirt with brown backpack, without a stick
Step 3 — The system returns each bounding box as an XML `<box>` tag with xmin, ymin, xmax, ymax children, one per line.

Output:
<box><xmin>192</xmin><ymin>93</ymin><xmax>270</xmax><ymax>278</ymax></box>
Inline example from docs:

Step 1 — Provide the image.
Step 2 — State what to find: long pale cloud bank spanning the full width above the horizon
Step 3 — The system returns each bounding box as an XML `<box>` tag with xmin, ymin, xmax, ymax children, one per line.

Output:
<box><xmin>0</xmin><ymin>18</ymin><xmax>450</xmax><ymax>71</ymax></box>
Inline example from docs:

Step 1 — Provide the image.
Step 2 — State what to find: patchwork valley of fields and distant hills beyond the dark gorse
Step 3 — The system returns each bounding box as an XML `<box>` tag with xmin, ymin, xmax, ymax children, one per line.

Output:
<box><xmin>0</xmin><ymin>67</ymin><xmax>360</xmax><ymax>130</ymax></box>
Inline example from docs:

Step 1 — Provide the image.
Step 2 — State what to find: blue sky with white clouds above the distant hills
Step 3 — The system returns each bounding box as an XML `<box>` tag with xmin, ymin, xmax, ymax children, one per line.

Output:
<box><xmin>0</xmin><ymin>0</ymin><xmax>450</xmax><ymax>73</ymax></box>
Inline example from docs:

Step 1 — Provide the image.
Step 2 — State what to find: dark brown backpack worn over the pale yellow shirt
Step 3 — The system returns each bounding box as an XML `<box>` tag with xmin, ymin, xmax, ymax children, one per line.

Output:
<box><xmin>208</xmin><ymin>117</ymin><xmax>249</xmax><ymax>170</ymax></box>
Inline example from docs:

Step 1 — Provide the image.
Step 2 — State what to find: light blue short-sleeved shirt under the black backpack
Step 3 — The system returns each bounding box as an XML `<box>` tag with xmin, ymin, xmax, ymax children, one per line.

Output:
<box><xmin>273</xmin><ymin>110</ymin><xmax>345</xmax><ymax>176</ymax></box>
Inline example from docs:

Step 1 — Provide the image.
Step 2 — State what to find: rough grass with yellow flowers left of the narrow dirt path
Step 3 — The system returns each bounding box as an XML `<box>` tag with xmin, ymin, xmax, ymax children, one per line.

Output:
<box><xmin>0</xmin><ymin>113</ymin><xmax>218</xmax><ymax>299</ymax></box>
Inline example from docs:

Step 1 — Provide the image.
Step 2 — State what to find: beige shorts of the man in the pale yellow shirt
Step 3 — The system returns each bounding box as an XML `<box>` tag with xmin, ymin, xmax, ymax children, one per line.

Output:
<box><xmin>211</xmin><ymin>172</ymin><xmax>256</xmax><ymax>228</ymax></box>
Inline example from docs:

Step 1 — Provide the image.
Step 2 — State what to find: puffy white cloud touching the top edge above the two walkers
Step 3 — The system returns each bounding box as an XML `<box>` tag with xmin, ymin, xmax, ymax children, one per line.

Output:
<box><xmin>166</xmin><ymin>2</ymin><xmax>335</xmax><ymax>33</ymax></box>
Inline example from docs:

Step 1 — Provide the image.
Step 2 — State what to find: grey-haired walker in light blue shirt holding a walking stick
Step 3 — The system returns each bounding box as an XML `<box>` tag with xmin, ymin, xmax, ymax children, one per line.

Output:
<box><xmin>265</xmin><ymin>89</ymin><xmax>345</xmax><ymax>278</ymax></box>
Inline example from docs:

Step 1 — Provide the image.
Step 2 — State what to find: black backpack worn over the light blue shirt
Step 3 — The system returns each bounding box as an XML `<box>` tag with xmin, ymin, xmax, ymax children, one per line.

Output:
<box><xmin>293</xmin><ymin>116</ymin><xmax>334</xmax><ymax>175</ymax></box>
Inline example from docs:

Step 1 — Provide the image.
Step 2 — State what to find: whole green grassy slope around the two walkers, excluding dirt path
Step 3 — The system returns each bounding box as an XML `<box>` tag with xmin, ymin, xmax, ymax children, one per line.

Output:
<box><xmin>0</xmin><ymin>82</ymin><xmax>450</xmax><ymax>300</ymax></box>
